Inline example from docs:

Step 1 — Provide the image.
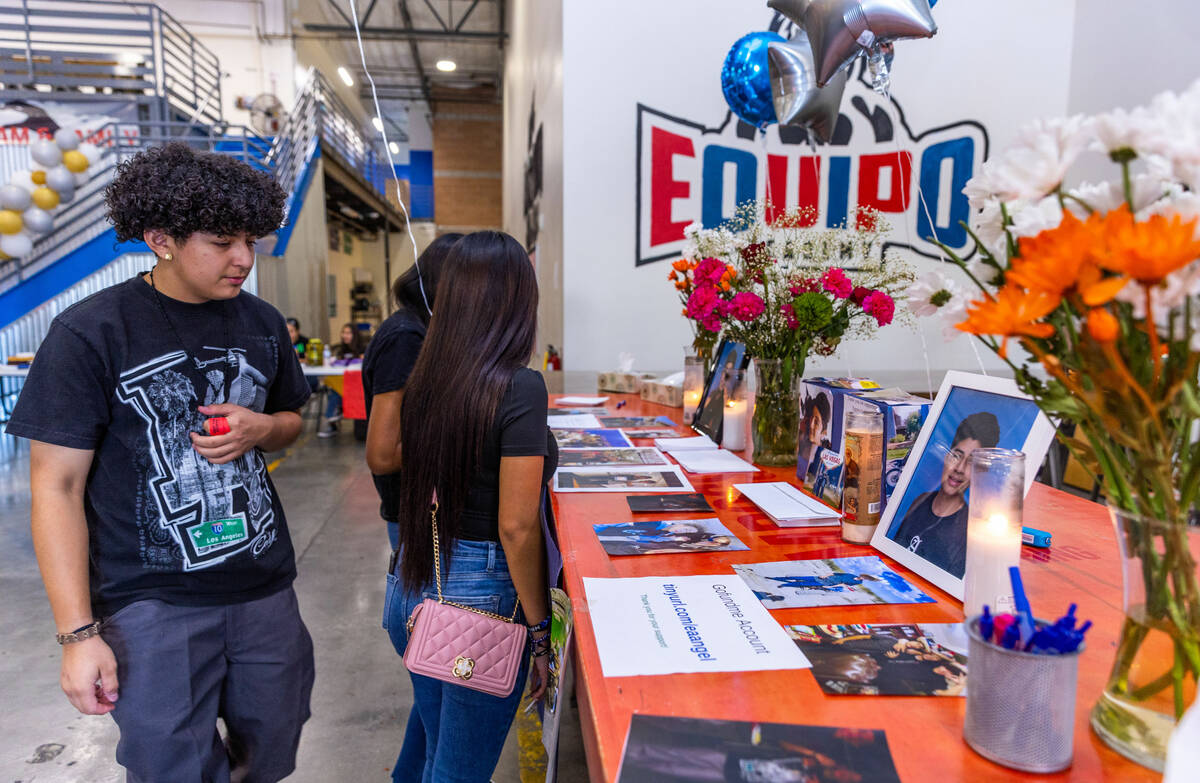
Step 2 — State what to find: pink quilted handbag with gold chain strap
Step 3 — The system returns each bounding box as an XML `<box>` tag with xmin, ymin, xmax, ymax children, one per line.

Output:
<box><xmin>404</xmin><ymin>501</ymin><xmax>526</xmax><ymax>698</ymax></box>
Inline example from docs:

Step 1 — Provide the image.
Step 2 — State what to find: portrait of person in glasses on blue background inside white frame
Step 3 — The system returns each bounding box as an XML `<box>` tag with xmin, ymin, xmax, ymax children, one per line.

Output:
<box><xmin>887</xmin><ymin>388</ymin><xmax>1038</xmax><ymax>579</ymax></box>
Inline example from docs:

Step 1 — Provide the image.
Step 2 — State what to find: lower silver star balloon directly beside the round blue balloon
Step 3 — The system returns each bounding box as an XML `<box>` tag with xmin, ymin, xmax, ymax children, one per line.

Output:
<box><xmin>767</xmin><ymin>30</ymin><xmax>847</xmax><ymax>143</ymax></box>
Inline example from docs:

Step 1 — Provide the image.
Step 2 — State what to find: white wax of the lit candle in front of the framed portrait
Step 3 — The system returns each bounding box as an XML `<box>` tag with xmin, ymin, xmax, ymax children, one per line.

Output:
<box><xmin>962</xmin><ymin>513</ymin><xmax>1021</xmax><ymax>617</ymax></box>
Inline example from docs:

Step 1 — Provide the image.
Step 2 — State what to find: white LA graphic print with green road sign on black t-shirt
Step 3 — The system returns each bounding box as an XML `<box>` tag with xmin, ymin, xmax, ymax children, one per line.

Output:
<box><xmin>116</xmin><ymin>346</ymin><xmax>277</xmax><ymax>572</ymax></box>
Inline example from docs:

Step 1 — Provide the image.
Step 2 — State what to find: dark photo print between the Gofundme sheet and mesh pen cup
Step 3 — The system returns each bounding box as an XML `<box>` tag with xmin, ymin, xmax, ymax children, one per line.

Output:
<box><xmin>784</xmin><ymin>622</ymin><xmax>967</xmax><ymax>697</ymax></box>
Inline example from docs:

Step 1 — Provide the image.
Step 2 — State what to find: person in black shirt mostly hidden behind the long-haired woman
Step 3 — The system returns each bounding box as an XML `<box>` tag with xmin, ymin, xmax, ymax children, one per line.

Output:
<box><xmin>362</xmin><ymin>233</ymin><xmax>462</xmax><ymax>549</ymax></box>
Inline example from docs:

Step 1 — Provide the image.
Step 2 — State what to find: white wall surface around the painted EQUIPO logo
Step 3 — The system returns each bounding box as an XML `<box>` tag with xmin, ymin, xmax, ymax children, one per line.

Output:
<box><xmin>556</xmin><ymin>0</ymin><xmax>1084</xmax><ymax>387</ymax></box>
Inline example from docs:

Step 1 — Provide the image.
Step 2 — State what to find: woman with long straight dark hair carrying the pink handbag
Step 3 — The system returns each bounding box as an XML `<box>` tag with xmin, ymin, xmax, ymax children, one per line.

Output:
<box><xmin>384</xmin><ymin>232</ymin><xmax>558</xmax><ymax>781</ymax></box>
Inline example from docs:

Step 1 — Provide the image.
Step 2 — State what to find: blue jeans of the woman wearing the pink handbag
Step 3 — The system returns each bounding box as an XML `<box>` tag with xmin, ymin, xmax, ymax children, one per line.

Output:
<box><xmin>383</xmin><ymin>540</ymin><xmax>529</xmax><ymax>783</ymax></box>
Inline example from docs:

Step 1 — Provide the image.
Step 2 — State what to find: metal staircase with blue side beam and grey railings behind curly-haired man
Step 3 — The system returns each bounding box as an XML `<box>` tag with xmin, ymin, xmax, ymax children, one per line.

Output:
<box><xmin>0</xmin><ymin>0</ymin><xmax>403</xmax><ymax>360</ymax></box>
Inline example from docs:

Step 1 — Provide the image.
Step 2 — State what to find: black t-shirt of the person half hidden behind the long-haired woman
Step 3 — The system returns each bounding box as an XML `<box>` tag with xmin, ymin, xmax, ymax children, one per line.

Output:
<box><xmin>362</xmin><ymin>307</ymin><xmax>425</xmax><ymax>522</ymax></box>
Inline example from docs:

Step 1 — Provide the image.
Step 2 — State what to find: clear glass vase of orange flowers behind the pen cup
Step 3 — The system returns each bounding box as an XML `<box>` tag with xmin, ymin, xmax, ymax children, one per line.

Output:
<box><xmin>1091</xmin><ymin>508</ymin><xmax>1200</xmax><ymax>772</ymax></box>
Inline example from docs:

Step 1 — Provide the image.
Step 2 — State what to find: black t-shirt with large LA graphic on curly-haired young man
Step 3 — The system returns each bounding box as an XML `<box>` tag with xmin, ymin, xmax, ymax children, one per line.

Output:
<box><xmin>7</xmin><ymin>276</ymin><xmax>310</xmax><ymax>617</ymax></box>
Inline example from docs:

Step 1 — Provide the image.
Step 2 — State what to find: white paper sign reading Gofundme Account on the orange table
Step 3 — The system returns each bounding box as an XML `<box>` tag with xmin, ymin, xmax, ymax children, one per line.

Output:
<box><xmin>583</xmin><ymin>574</ymin><xmax>810</xmax><ymax>677</ymax></box>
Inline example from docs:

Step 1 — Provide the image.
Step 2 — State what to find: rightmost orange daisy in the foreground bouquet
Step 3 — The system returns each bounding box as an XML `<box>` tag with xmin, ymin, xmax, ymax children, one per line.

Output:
<box><xmin>1097</xmin><ymin>205</ymin><xmax>1200</xmax><ymax>287</ymax></box>
